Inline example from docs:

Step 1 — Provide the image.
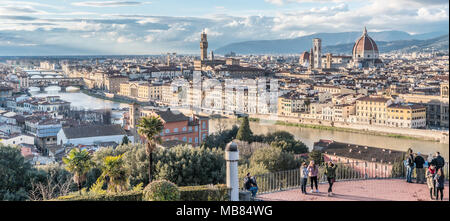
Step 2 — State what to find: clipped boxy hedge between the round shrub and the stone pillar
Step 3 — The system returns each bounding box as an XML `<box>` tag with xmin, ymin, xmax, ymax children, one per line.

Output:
<box><xmin>179</xmin><ymin>184</ymin><xmax>230</xmax><ymax>201</ymax></box>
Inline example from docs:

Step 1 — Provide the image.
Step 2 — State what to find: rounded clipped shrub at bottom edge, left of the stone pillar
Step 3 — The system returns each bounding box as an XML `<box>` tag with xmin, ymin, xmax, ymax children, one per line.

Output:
<box><xmin>142</xmin><ymin>180</ymin><xmax>180</xmax><ymax>201</ymax></box>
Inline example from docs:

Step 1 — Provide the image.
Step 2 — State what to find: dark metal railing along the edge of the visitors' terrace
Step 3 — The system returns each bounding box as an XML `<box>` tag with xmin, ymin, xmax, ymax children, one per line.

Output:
<box><xmin>243</xmin><ymin>162</ymin><xmax>449</xmax><ymax>194</ymax></box>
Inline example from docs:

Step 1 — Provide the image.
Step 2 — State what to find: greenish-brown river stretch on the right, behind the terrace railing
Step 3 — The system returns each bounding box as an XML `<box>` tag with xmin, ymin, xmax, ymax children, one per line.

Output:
<box><xmin>209</xmin><ymin>119</ymin><xmax>449</xmax><ymax>161</ymax></box>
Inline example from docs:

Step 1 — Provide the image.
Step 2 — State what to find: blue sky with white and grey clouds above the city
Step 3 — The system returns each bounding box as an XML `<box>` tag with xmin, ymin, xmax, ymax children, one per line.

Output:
<box><xmin>0</xmin><ymin>0</ymin><xmax>449</xmax><ymax>54</ymax></box>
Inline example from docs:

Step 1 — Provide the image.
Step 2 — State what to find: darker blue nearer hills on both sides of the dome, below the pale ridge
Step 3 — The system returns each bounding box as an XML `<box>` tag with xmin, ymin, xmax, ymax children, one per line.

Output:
<box><xmin>322</xmin><ymin>34</ymin><xmax>449</xmax><ymax>55</ymax></box>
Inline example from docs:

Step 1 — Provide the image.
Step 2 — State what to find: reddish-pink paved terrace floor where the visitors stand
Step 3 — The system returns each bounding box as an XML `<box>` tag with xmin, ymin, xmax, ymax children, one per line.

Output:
<box><xmin>257</xmin><ymin>179</ymin><xmax>449</xmax><ymax>201</ymax></box>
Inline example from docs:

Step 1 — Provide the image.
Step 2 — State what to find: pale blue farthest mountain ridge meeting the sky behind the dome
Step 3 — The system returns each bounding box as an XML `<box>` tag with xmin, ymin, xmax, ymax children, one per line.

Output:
<box><xmin>214</xmin><ymin>31</ymin><xmax>448</xmax><ymax>54</ymax></box>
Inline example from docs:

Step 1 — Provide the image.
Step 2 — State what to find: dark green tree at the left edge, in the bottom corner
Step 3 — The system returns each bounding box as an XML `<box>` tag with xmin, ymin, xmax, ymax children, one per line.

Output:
<box><xmin>0</xmin><ymin>144</ymin><xmax>34</xmax><ymax>201</ymax></box>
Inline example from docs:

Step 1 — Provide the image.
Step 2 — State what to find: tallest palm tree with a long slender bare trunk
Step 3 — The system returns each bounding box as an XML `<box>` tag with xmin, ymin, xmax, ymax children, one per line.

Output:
<box><xmin>138</xmin><ymin>116</ymin><xmax>164</xmax><ymax>183</ymax></box>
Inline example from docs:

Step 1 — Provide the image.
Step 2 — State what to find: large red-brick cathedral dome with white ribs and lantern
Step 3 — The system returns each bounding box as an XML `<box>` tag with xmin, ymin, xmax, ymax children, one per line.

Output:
<box><xmin>353</xmin><ymin>28</ymin><xmax>379</xmax><ymax>60</ymax></box>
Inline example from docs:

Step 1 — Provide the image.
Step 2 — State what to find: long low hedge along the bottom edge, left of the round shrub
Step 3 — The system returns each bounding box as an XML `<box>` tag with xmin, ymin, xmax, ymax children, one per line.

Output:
<box><xmin>54</xmin><ymin>191</ymin><xmax>142</xmax><ymax>201</ymax></box>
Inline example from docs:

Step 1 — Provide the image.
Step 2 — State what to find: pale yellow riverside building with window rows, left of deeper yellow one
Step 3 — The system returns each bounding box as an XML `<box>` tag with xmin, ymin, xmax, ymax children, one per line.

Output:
<box><xmin>356</xmin><ymin>96</ymin><xmax>392</xmax><ymax>125</ymax></box>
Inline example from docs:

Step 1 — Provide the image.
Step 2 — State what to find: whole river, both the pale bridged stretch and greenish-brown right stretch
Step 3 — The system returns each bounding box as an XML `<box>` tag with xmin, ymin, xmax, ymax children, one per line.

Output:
<box><xmin>31</xmin><ymin>88</ymin><xmax>449</xmax><ymax>161</ymax></box>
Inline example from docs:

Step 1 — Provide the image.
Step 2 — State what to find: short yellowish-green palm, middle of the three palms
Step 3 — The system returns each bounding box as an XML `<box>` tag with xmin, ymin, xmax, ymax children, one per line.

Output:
<box><xmin>100</xmin><ymin>154</ymin><xmax>127</xmax><ymax>192</ymax></box>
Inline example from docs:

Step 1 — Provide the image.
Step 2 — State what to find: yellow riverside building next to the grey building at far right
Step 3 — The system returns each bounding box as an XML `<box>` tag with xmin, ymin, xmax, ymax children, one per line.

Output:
<box><xmin>387</xmin><ymin>104</ymin><xmax>427</xmax><ymax>128</ymax></box>
